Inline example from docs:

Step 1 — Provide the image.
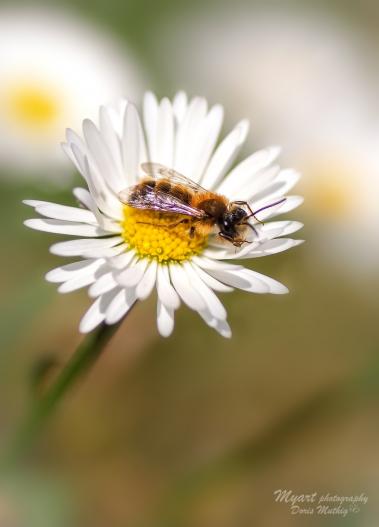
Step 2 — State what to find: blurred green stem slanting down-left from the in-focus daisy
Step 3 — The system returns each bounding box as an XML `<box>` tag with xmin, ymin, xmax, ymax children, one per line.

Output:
<box><xmin>0</xmin><ymin>316</ymin><xmax>130</xmax><ymax>471</ymax></box>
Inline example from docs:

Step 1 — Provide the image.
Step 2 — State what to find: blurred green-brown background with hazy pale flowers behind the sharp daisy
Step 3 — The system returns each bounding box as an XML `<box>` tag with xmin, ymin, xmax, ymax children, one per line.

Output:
<box><xmin>0</xmin><ymin>0</ymin><xmax>379</xmax><ymax>527</ymax></box>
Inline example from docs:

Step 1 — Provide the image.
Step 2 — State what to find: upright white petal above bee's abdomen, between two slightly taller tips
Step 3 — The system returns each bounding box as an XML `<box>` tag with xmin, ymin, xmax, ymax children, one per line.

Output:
<box><xmin>154</xmin><ymin>97</ymin><xmax>174</xmax><ymax>167</ymax></box>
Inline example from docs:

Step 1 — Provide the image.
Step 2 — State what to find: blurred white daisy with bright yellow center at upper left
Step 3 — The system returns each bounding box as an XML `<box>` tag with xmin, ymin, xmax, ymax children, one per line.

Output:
<box><xmin>0</xmin><ymin>7</ymin><xmax>142</xmax><ymax>175</ymax></box>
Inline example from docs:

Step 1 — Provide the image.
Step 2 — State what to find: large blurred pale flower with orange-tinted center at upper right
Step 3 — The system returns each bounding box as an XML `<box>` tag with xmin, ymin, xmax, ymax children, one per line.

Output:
<box><xmin>158</xmin><ymin>8</ymin><xmax>379</xmax><ymax>280</ymax></box>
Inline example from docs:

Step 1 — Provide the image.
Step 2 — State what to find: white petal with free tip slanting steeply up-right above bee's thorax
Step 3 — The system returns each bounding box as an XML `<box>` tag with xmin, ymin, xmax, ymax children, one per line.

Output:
<box><xmin>201</xmin><ymin>120</ymin><xmax>249</xmax><ymax>189</ymax></box>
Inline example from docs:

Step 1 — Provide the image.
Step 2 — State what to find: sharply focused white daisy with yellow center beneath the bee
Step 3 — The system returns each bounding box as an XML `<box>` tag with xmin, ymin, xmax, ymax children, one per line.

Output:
<box><xmin>25</xmin><ymin>92</ymin><xmax>302</xmax><ymax>337</ymax></box>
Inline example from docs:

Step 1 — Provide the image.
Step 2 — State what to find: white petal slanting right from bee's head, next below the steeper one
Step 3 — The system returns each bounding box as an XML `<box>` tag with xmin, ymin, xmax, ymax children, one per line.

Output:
<box><xmin>218</xmin><ymin>147</ymin><xmax>280</xmax><ymax>199</ymax></box>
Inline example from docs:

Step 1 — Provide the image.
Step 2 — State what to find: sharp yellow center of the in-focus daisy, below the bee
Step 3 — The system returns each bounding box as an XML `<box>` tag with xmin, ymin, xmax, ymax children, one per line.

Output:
<box><xmin>122</xmin><ymin>206</ymin><xmax>208</xmax><ymax>263</ymax></box>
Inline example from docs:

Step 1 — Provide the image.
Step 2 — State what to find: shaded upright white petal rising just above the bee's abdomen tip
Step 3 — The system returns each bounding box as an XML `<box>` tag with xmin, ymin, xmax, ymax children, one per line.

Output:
<box><xmin>121</xmin><ymin>103</ymin><xmax>147</xmax><ymax>186</ymax></box>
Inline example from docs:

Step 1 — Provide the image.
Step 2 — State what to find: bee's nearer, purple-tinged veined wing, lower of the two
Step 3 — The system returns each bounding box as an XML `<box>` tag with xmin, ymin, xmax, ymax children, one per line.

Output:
<box><xmin>118</xmin><ymin>184</ymin><xmax>206</xmax><ymax>219</ymax></box>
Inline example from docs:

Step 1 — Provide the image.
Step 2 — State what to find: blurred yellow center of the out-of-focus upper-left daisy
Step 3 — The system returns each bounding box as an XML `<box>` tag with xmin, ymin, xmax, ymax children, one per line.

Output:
<box><xmin>7</xmin><ymin>84</ymin><xmax>60</xmax><ymax>129</ymax></box>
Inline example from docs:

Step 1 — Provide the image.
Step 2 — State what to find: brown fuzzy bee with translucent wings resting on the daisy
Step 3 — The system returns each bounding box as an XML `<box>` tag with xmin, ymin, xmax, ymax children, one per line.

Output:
<box><xmin>118</xmin><ymin>163</ymin><xmax>285</xmax><ymax>247</ymax></box>
